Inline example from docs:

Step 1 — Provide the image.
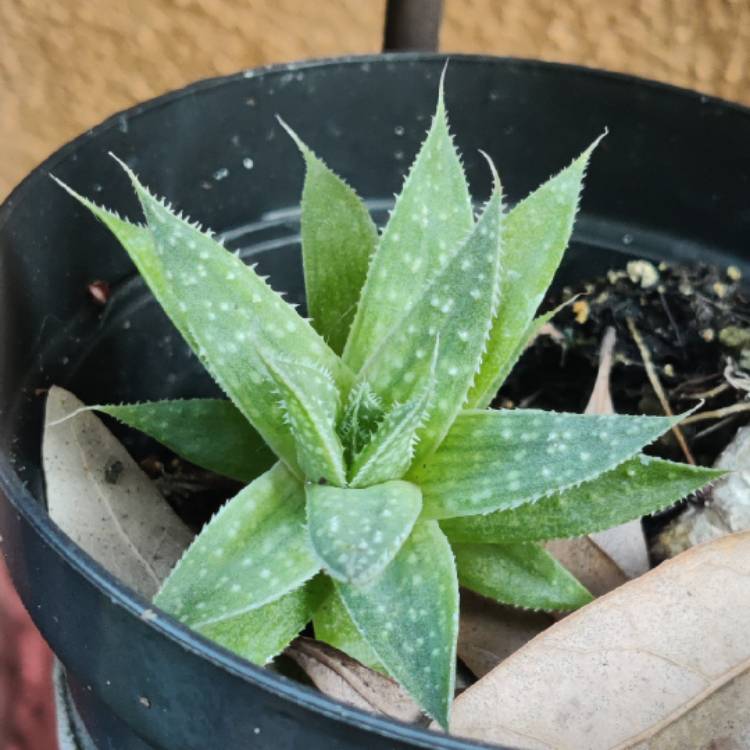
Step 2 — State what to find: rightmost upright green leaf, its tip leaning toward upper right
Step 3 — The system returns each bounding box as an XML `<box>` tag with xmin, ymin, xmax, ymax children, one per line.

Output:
<box><xmin>467</xmin><ymin>136</ymin><xmax>603</xmax><ymax>408</ymax></box>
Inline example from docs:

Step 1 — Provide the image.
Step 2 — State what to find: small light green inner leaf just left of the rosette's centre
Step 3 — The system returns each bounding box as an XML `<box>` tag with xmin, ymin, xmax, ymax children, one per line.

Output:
<box><xmin>257</xmin><ymin>346</ymin><xmax>346</xmax><ymax>485</ymax></box>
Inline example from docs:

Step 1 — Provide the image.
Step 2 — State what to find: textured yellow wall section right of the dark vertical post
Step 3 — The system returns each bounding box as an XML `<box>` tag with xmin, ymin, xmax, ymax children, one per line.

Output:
<box><xmin>441</xmin><ymin>0</ymin><xmax>750</xmax><ymax>104</ymax></box>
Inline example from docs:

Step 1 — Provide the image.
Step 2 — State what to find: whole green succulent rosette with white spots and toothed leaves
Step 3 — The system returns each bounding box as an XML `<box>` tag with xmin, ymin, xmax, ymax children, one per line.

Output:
<box><xmin>54</xmin><ymin>75</ymin><xmax>718</xmax><ymax>727</ymax></box>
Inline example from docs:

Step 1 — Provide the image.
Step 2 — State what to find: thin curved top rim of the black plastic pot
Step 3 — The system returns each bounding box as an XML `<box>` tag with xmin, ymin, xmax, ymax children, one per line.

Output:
<box><xmin>0</xmin><ymin>52</ymin><xmax>750</xmax><ymax>750</ymax></box>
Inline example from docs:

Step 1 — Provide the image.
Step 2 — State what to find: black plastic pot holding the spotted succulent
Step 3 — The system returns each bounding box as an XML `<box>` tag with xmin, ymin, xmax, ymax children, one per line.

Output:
<box><xmin>0</xmin><ymin>55</ymin><xmax>750</xmax><ymax>750</ymax></box>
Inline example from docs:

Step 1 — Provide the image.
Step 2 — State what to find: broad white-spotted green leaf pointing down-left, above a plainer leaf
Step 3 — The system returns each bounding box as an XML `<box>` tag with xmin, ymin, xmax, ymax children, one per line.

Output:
<box><xmin>154</xmin><ymin>463</ymin><xmax>320</xmax><ymax>632</ymax></box>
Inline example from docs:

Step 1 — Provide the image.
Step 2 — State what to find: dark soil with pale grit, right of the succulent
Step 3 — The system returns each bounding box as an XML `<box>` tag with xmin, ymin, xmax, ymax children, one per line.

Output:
<box><xmin>495</xmin><ymin>261</ymin><xmax>750</xmax><ymax>535</ymax></box>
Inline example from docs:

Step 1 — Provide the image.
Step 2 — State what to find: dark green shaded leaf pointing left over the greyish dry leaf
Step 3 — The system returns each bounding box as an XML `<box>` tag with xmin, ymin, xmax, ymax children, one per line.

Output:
<box><xmin>88</xmin><ymin>398</ymin><xmax>275</xmax><ymax>482</ymax></box>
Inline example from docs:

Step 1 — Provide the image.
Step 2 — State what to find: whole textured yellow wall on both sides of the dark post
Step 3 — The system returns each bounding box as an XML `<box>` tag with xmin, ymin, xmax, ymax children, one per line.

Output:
<box><xmin>0</xmin><ymin>0</ymin><xmax>750</xmax><ymax>197</ymax></box>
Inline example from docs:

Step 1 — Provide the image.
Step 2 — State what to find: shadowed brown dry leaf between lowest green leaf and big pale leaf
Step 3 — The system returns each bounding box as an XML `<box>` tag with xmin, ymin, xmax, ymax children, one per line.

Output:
<box><xmin>458</xmin><ymin>589</ymin><xmax>554</xmax><ymax>677</ymax></box>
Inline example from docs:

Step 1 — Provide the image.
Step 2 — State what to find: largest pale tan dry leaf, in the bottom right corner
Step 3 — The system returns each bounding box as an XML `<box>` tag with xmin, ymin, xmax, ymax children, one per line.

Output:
<box><xmin>451</xmin><ymin>532</ymin><xmax>750</xmax><ymax>750</ymax></box>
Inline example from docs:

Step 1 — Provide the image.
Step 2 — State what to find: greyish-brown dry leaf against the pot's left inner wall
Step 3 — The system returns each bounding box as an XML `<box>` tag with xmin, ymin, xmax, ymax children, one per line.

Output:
<box><xmin>42</xmin><ymin>387</ymin><xmax>193</xmax><ymax>599</ymax></box>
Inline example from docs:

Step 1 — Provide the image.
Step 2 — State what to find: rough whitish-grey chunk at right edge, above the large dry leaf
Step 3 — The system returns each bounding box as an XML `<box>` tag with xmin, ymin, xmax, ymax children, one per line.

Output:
<box><xmin>654</xmin><ymin>427</ymin><xmax>750</xmax><ymax>557</ymax></box>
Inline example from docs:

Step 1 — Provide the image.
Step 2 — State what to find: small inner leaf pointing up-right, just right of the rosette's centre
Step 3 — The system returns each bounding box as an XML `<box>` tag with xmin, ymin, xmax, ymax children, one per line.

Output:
<box><xmin>349</xmin><ymin>341</ymin><xmax>438</xmax><ymax>487</ymax></box>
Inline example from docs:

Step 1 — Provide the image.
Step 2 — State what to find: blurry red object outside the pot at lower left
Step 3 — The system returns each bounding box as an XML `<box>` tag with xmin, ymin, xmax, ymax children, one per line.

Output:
<box><xmin>0</xmin><ymin>557</ymin><xmax>57</xmax><ymax>750</ymax></box>
